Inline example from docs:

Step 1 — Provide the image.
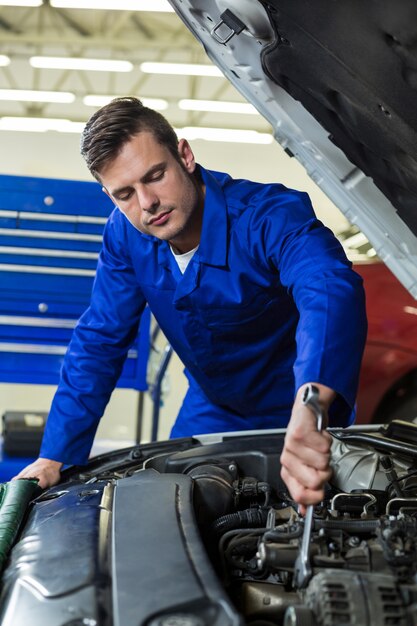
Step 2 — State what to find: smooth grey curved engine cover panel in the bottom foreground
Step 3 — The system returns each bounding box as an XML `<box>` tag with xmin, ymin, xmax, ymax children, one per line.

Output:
<box><xmin>112</xmin><ymin>470</ymin><xmax>242</xmax><ymax>626</ymax></box>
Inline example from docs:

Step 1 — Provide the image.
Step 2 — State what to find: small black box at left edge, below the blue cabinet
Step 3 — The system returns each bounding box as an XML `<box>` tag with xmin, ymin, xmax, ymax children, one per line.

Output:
<box><xmin>2</xmin><ymin>411</ymin><xmax>48</xmax><ymax>457</ymax></box>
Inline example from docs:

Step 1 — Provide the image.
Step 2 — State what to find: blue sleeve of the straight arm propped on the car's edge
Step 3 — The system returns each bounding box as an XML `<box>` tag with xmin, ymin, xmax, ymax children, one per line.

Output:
<box><xmin>40</xmin><ymin>209</ymin><xmax>146</xmax><ymax>464</ymax></box>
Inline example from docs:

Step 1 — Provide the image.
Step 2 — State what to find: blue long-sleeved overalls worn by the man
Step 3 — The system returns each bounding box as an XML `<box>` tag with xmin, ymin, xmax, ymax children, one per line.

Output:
<box><xmin>41</xmin><ymin>167</ymin><xmax>366</xmax><ymax>463</ymax></box>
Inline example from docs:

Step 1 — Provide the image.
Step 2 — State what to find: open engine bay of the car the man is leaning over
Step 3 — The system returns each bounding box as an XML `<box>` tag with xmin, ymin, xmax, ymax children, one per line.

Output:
<box><xmin>0</xmin><ymin>421</ymin><xmax>417</xmax><ymax>626</ymax></box>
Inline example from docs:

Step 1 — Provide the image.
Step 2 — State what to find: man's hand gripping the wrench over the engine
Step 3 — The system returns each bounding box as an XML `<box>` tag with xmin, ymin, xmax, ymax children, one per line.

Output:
<box><xmin>281</xmin><ymin>383</ymin><xmax>336</xmax><ymax>514</ymax></box>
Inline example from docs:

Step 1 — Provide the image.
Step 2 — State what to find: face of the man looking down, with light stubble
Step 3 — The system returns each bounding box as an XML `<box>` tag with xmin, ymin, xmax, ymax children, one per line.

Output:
<box><xmin>100</xmin><ymin>131</ymin><xmax>204</xmax><ymax>252</ymax></box>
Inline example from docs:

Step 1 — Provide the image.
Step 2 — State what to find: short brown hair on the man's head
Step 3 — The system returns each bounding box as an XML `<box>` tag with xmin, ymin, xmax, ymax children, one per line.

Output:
<box><xmin>81</xmin><ymin>96</ymin><xmax>179</xmax><ymax>180</ymax></box>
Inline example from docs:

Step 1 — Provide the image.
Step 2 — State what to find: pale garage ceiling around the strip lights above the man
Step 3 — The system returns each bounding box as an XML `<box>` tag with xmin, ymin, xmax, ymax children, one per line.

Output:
<box><xmin>0</xmin><ymin>0</ymin><xmax>270</xmax><ymax>132</ymax></box>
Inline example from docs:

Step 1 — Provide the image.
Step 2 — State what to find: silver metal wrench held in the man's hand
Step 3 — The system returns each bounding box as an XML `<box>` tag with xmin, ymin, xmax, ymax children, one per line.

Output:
<box><xmin>294</xmin><ymin>385</ymin><xmax>323</xmax><ymax>589</ymax></box>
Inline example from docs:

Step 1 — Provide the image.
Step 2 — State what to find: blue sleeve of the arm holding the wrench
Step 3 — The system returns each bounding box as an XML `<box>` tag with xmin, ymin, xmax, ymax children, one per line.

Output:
<box><xmin>249</xmin><ymin>185</ymin><xmax>367</xmax><ymax>425</ymax></box>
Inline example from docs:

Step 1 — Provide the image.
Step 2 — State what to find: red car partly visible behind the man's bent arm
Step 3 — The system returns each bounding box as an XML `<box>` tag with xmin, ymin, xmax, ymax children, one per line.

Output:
<box><xmin>339</xmin><ymin>227</ymin><xmax>417</xmax><ymax>424</ymax></box>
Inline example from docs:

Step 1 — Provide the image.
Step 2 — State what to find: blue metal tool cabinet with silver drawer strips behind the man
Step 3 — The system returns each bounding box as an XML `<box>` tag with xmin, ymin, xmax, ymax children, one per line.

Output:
<box><xmin>0</xmin><ymin>175</ymin><xmax>150</xmax><ymax>390</ymax></box>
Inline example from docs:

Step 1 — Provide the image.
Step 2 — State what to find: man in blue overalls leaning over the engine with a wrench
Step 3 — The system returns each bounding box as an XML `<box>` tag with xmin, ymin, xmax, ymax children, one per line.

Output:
<box><xmin>18</xmin><ymin>97</ymin><xmax>366</xmax><ymax>510</ymax></box>
